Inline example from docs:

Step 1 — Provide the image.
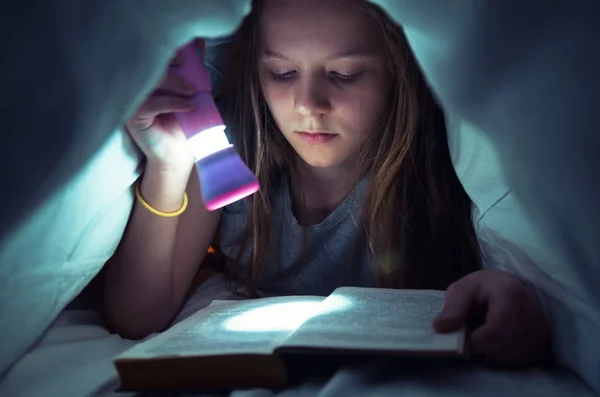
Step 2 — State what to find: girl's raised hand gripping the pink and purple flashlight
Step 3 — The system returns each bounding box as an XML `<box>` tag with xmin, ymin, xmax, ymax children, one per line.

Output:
<box><xmin>126</xmin><ymin>53</ymin><xmax>196</xmax><ymax>171</ymax></box>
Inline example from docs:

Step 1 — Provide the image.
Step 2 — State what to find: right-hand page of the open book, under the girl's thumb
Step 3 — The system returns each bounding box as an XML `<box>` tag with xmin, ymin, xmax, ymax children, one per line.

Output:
<box><xmin>284</xmin><ymin>287</ymin><xmax>464</xmax><ymax>352</ymax></box>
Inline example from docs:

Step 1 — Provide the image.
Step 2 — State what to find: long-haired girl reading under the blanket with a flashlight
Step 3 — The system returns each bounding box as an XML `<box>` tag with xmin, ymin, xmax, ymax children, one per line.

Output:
<box><xmin>106</xmin><ymin>0</ymin><xmax>548</xmax><ymax>366</ymax></box>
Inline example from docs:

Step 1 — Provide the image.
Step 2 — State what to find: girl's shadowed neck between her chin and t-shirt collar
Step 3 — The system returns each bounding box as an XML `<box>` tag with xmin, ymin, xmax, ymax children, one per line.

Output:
<box><xmin>292</xmin><ymin>153</ymin><xmax>359</xmax><ymax>225</ymax></box>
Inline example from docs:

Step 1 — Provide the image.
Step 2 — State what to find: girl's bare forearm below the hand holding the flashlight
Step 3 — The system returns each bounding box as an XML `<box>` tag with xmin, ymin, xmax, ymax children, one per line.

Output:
<box><xmin>105</xmin><ymin>164</ymin><xmax>221</xmax><ymax>338</ymax></box>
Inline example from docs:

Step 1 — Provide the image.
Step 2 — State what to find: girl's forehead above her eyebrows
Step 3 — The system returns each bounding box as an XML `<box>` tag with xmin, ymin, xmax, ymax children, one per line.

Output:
<box><xmin>260</xmin><ymin>0</ymin><xmax>383</xmax><ymax>56</ymax></box>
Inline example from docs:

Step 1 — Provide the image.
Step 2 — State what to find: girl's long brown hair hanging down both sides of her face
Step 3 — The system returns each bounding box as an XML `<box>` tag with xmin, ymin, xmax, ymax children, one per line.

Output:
<box><xmin>220</xmin><ymin>0</ymin><xmax>480</xmax><ymax>294</ymax></box>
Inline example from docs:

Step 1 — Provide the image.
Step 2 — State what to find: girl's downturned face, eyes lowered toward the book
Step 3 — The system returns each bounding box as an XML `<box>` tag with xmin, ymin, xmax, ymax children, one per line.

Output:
<box><xmin>258</xmin><ymin>0</ymin><xmax>392</xmax><ymax>167</ymax></box>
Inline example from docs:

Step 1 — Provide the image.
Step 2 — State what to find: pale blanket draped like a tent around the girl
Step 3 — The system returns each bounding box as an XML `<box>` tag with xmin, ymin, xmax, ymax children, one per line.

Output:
<box><xmin>0</xmin><ymin>0</ymin><xmax>600</xmax><ymax>396</ymax></box>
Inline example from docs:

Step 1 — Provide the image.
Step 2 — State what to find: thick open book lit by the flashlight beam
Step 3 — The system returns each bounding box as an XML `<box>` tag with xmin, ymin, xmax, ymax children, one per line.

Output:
<box><xmin>115</xmin><ymin>287</ymin><xmax>465</xmax><ymax>390</ymax></box>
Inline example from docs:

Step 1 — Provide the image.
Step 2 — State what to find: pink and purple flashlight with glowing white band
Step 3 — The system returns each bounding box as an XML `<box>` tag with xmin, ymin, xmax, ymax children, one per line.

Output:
<box><xmin>173</xmin><ymin>42</ymin><xmax>259</xmax><ymax>211</ymax></box>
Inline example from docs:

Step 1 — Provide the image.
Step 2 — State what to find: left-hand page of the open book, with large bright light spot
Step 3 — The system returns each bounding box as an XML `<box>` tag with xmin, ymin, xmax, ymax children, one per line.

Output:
<box><xmin>117</xmin><ymin>296</ymin><xmax>324</xmax><ymax>359</ymax></box>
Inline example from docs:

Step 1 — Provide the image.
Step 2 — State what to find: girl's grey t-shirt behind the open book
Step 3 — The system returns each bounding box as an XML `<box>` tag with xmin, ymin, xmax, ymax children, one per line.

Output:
<box><xmin>219</xmin><ymin>174</ymin><xmax>374</xmax><ymax>295</ymax></box>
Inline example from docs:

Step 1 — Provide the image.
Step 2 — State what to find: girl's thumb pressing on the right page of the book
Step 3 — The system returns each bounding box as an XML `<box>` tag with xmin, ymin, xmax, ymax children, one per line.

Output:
<box><xmin>433</xmin><ymin>273</ymin><xmax>479</xmax><ymax>332</ymax></box>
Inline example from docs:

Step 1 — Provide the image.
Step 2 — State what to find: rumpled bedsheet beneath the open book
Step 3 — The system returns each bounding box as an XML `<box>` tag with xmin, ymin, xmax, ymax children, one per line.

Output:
<box><xmin>0</xmin><ymin>276</ymin><xmax>595</xmax><ymax>397</ymax></box>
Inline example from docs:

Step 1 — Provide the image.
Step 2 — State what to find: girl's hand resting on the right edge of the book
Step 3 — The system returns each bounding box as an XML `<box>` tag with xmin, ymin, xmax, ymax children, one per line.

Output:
<box><xmin>434</xmin><ymin>270</ymin><xmax>551</xmax><ymax>368</ymax></box>
